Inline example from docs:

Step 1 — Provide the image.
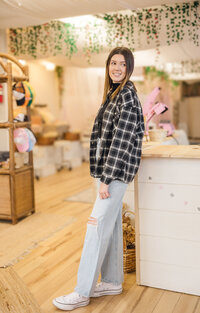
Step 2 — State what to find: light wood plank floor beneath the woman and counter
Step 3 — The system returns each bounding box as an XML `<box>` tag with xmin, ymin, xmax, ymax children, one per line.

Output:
<box><xmin>2</xmin><ymin>163</ymin><xmax>200</xmax><ymax>313</ymax></box>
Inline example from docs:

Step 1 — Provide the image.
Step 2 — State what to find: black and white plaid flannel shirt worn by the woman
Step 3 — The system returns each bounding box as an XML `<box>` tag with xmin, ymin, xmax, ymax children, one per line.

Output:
<box><xmin>90</xmin><ymin>81</ymin><xmax>144</xmax><ymax>184</ymax></box>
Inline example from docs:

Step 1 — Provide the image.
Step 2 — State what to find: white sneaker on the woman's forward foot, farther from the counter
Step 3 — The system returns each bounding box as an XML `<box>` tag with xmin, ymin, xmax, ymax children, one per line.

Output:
<box><xmin>53</xmin><ymin>292</ymin><xmax>90</xmax><ymax>311</ymax></box>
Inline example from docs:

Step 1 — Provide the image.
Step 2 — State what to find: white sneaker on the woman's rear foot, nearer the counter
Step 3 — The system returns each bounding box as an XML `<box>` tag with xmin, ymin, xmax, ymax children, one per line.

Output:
<box><xmin>92</xmin><ymin>282</ymin><xmax>122</xmax><ymax>297</ymax></box>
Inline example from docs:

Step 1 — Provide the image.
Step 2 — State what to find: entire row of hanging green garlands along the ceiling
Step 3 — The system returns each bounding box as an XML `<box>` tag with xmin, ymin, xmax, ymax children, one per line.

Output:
<box><xmin>9</xmin><ymin>1</ymin><xmax>200</xmax><ymax>63</ymax></box>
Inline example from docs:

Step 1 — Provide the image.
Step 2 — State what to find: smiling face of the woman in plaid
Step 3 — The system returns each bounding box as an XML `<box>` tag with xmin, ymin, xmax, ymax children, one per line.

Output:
<box><xmin>108</xmin><ymin>54</ymin><xmax>126</xmax><ymax>83</ymax></box>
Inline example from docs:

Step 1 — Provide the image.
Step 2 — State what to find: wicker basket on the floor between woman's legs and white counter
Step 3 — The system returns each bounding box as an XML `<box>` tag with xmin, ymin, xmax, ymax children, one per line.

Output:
<box><xmin>123</xmin><ymin>211</ymin><xmax>136</xmax><ymax>273</ymax></box>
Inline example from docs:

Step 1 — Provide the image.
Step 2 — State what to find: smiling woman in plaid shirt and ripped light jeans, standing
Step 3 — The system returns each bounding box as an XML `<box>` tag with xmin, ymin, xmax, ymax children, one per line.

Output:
<box><xmin>53</xmin><ymin>47</ymin><xmax>144</xmax><ymax>311</ymax></box>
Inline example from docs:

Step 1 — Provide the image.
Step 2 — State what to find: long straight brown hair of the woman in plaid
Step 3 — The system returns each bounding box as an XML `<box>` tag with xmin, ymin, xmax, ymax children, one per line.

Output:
<box><xmin>103</xmin><ymin>47</ymin><xmax>136</xmax><ymax>102</ymax></box>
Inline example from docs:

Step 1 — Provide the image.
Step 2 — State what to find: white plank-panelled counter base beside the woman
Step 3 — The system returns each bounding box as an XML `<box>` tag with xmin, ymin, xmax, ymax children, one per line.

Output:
<box><xmin>136</xmin><ymin>147</ymin><xmax>200</xmax><ymax>295</ymax></box>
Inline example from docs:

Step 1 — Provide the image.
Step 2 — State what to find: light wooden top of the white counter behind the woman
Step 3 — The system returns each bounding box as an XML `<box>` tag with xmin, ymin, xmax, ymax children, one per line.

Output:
<box><xmin>142</xmin><ymin>142</ymin><xmax>200</xmax><ymax>159</ymax></box>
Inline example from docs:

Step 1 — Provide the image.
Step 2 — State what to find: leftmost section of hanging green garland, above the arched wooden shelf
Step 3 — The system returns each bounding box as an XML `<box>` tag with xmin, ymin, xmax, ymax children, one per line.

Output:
<box><xmin>9</xmin><ymin>21</ymin><xmax>78</xmax><ymax>58</ymax></box>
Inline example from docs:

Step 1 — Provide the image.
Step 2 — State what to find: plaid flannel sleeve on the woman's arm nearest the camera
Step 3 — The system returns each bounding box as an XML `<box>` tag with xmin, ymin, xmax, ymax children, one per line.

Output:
<box><xmin>100</xmin><ymin>91</ymin><xmax>138</xmax><ymax>185</ymax></box>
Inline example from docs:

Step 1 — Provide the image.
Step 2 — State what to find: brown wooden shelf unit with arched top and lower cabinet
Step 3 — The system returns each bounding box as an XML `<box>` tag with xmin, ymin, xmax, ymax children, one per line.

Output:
<box><xmin>0</xmin><ymin>53</ymin><xmax>35</xmax><ymax>224</ymax></box>
